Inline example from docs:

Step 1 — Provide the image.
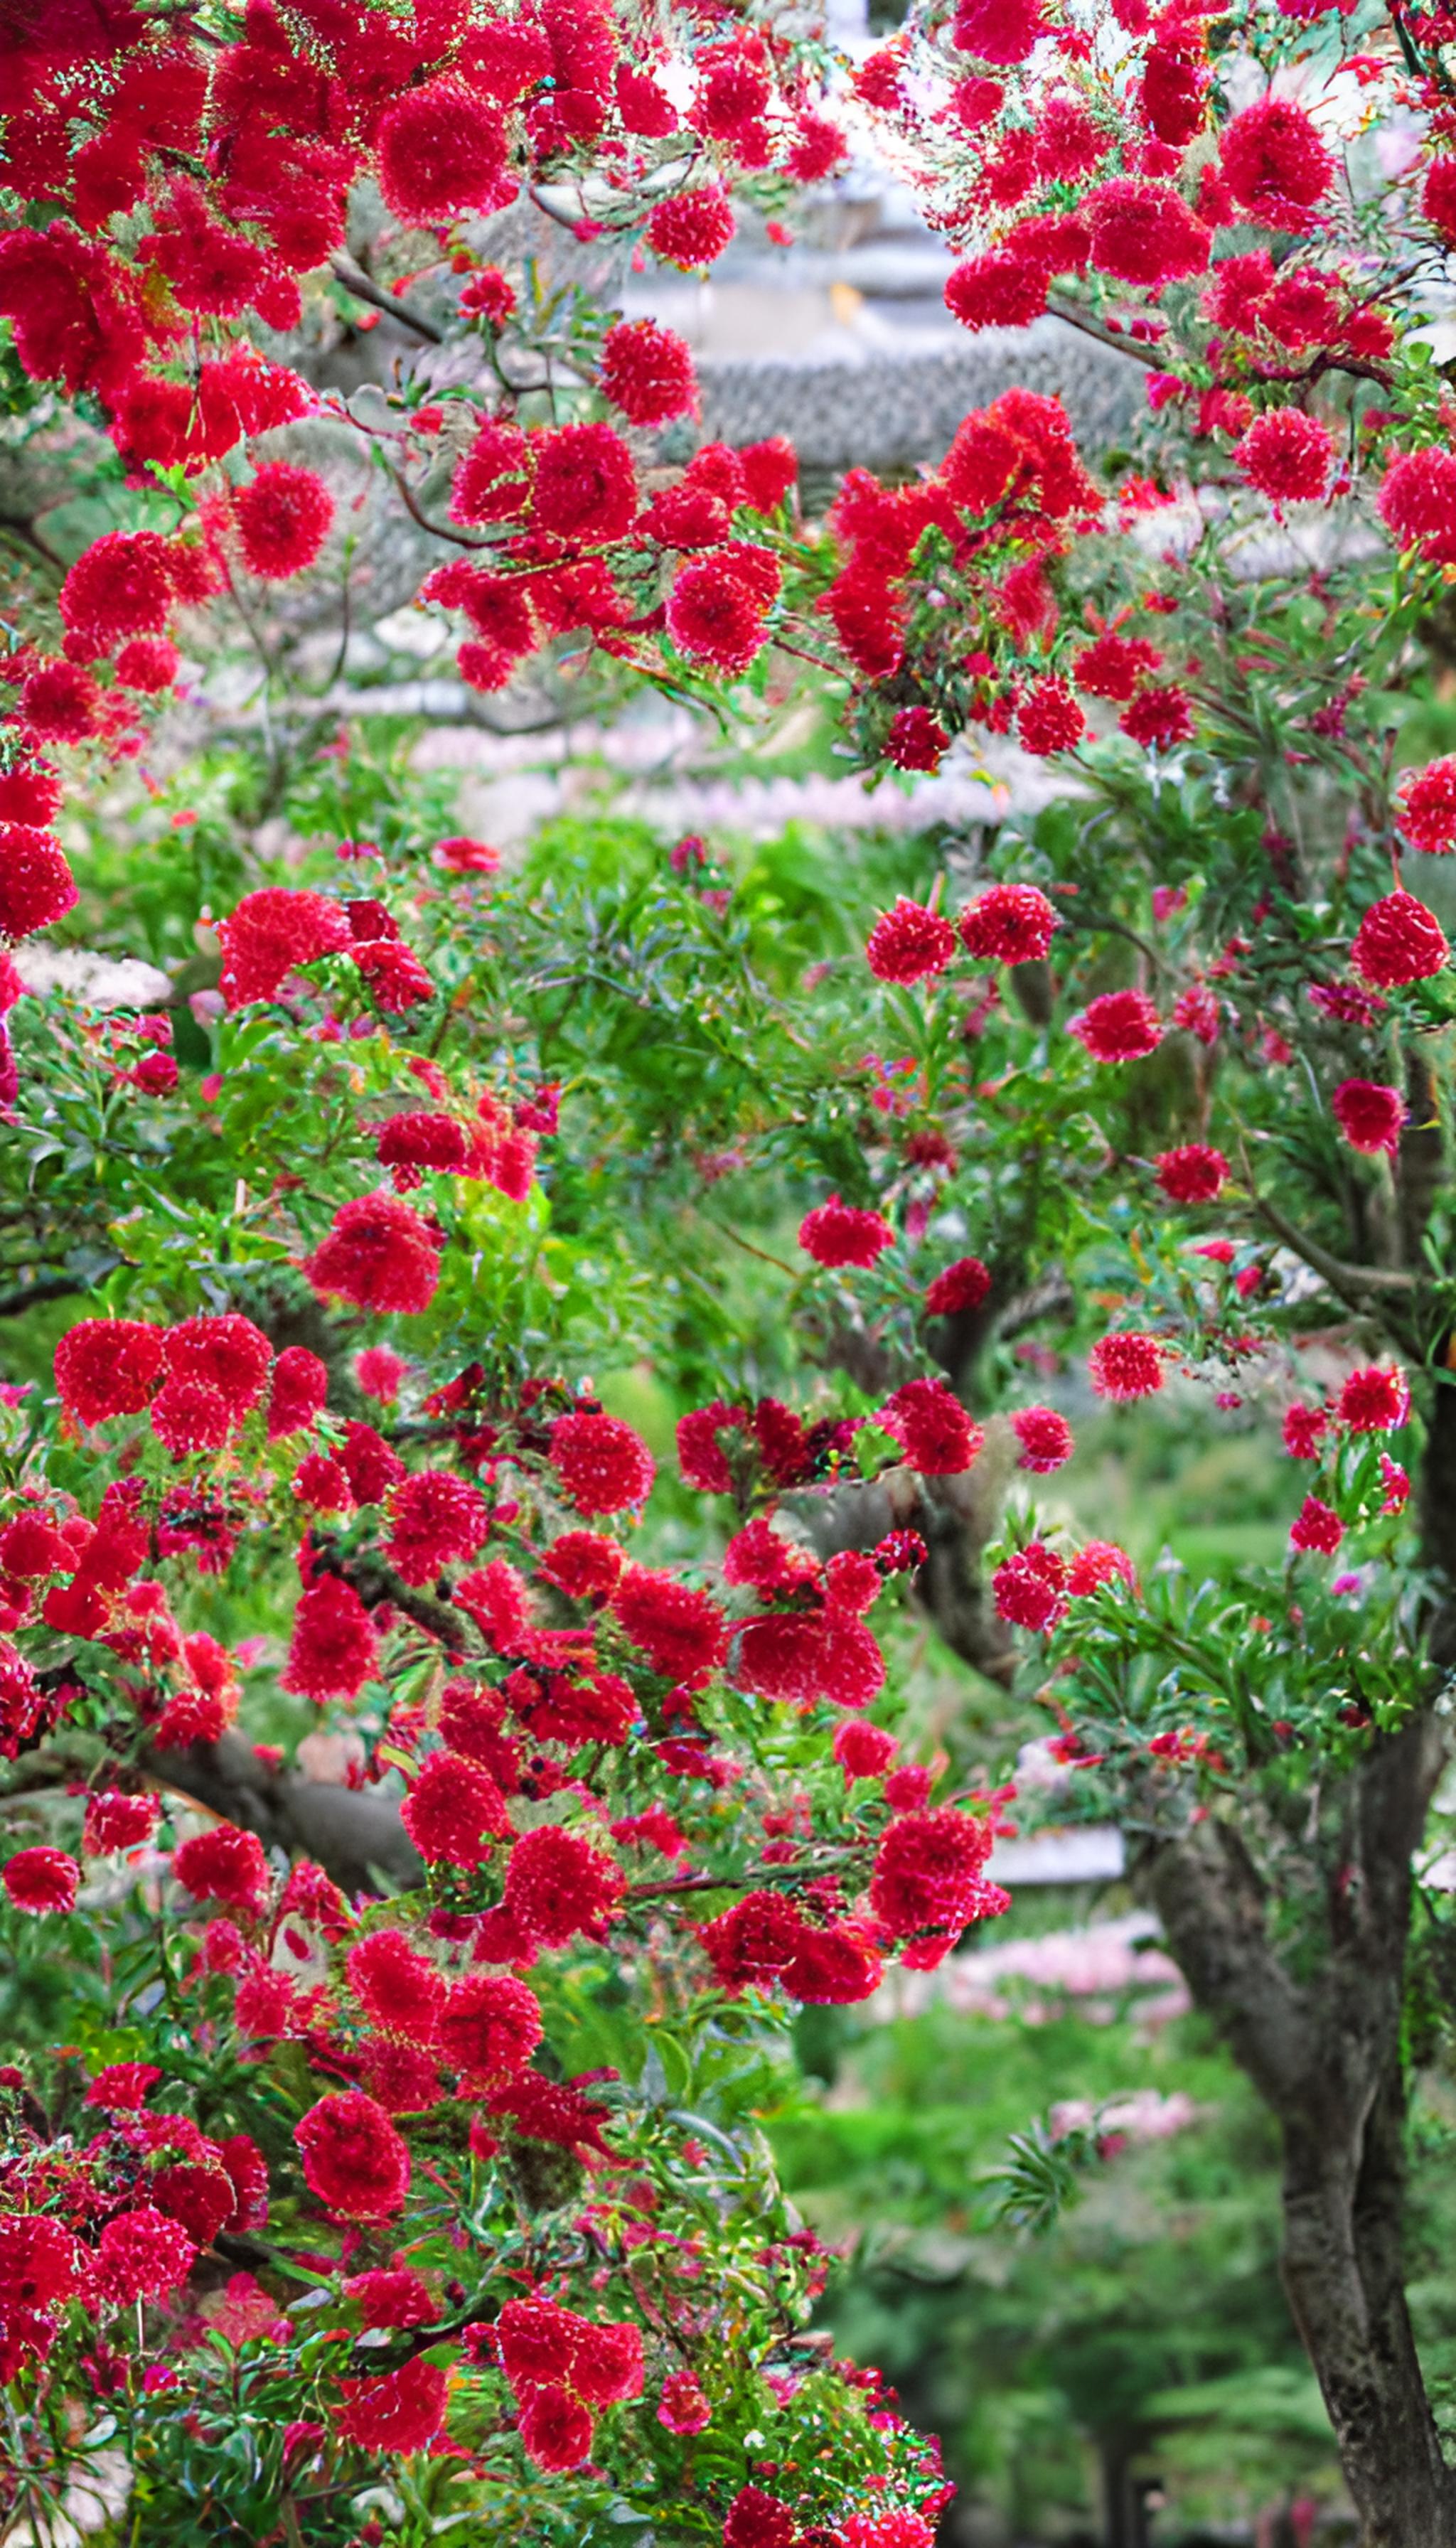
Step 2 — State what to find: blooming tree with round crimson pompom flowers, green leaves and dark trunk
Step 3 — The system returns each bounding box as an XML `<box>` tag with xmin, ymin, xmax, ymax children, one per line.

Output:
<box><xmin>11</xmin><ymin>0</ymin><xmax>1456</xmax><ymax>2548</ymax></box>
